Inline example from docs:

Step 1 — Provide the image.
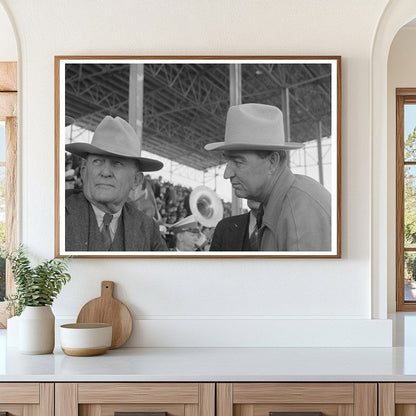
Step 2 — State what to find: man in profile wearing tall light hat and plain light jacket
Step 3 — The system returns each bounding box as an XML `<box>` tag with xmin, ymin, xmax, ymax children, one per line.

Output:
<box><xmin>205</xmin><ymin>104</ymin><xmax>331</xmax><ymax>251</ymax></box>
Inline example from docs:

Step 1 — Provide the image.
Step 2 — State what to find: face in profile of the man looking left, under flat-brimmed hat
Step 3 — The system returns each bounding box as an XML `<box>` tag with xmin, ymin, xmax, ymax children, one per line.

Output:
<box><xmin>224</xmin><ymin>151</ymin><xmax>271</xmax><ymax>201</ymax></box>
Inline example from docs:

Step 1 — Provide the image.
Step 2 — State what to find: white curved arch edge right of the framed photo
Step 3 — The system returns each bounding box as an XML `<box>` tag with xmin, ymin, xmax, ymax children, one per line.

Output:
<box><xmin>371</xmin><ymin>0</ymin><xmax>416</xmax><ymax>319</ymax></box>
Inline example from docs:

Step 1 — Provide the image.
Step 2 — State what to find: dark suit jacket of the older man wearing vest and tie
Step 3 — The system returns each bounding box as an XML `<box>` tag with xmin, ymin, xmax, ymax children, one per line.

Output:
<box><xmin>65</xmin><ymin>192</ymin><xmax>167</xmax><ymax>251</ymax></box>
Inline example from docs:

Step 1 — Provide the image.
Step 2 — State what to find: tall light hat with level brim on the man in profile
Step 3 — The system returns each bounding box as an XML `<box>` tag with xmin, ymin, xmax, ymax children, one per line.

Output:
<box><xmin>205</xmin><ymin>104</ymin><xmax>303</xmax><ymax>151</ymax></box>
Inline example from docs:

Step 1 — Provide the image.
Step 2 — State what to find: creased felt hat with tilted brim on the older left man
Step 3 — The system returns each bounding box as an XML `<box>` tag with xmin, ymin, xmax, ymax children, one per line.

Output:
<box><xmin>65</xmin><ymin>116</ymin><xmax>163</xmax><ymax>172</ymax></box>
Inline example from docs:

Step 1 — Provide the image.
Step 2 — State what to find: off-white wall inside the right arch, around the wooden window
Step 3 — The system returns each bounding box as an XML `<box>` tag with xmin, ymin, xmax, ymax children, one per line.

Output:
<box><xmin>387</xmin><ymin>26</ymin><xmax>416</xmax><ymax>312</ymax></box>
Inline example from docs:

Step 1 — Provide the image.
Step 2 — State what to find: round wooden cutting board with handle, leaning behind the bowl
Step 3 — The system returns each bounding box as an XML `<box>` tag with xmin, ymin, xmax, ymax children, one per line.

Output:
<box><xmin>77</xmin><ymin>281</ymin><xmax>133</xmax><ymax>349</ymax></box>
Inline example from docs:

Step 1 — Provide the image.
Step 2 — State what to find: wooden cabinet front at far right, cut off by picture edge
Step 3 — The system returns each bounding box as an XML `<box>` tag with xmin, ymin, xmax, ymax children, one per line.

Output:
<box><xmin>379</xmin><ymin>383</ymin><xmax>416</xmax><ymax>416</ymax></box>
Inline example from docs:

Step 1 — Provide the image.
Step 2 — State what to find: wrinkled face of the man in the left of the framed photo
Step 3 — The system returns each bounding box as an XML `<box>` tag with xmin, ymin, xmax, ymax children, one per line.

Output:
<box><xmin>81</xmin><ymin>155</ymin><xmax>141</xmax><ymax>213</ymax></box>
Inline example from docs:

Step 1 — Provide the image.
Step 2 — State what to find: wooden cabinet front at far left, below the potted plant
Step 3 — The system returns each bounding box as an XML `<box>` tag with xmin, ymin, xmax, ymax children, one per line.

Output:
<box><xmin>0</xmin><ymin>383</ymin><xmax>54</xmax><ymax>416</ymax></box>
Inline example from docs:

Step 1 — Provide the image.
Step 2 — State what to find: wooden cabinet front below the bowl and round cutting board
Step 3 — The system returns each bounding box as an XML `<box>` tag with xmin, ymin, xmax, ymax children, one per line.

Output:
<box><xmin>55</xmin><ymin>383</ymin><xmax>215</xmax><ymax>416</ymax></box>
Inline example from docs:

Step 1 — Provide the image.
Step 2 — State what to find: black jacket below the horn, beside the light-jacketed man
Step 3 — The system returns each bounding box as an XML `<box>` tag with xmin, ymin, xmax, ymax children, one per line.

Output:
<box><xmin>209</xmin><ymin>212</ymin><xmax>250</xmax><ymax>251</ymax></box>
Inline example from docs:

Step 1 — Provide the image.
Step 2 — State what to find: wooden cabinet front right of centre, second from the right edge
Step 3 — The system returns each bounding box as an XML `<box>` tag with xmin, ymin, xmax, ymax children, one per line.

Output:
<box><xmin>217</xmin><ymin>383</ymin><xmax>377</xmax><ymax>416</ymax></box>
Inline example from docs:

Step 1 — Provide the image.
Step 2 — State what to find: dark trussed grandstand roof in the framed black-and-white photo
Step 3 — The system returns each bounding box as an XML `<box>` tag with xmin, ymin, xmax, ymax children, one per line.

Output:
<box><xmin>65</xmin><ymin>62</ymin><xmax>331</xmax><ymax>170</ymax></box>
